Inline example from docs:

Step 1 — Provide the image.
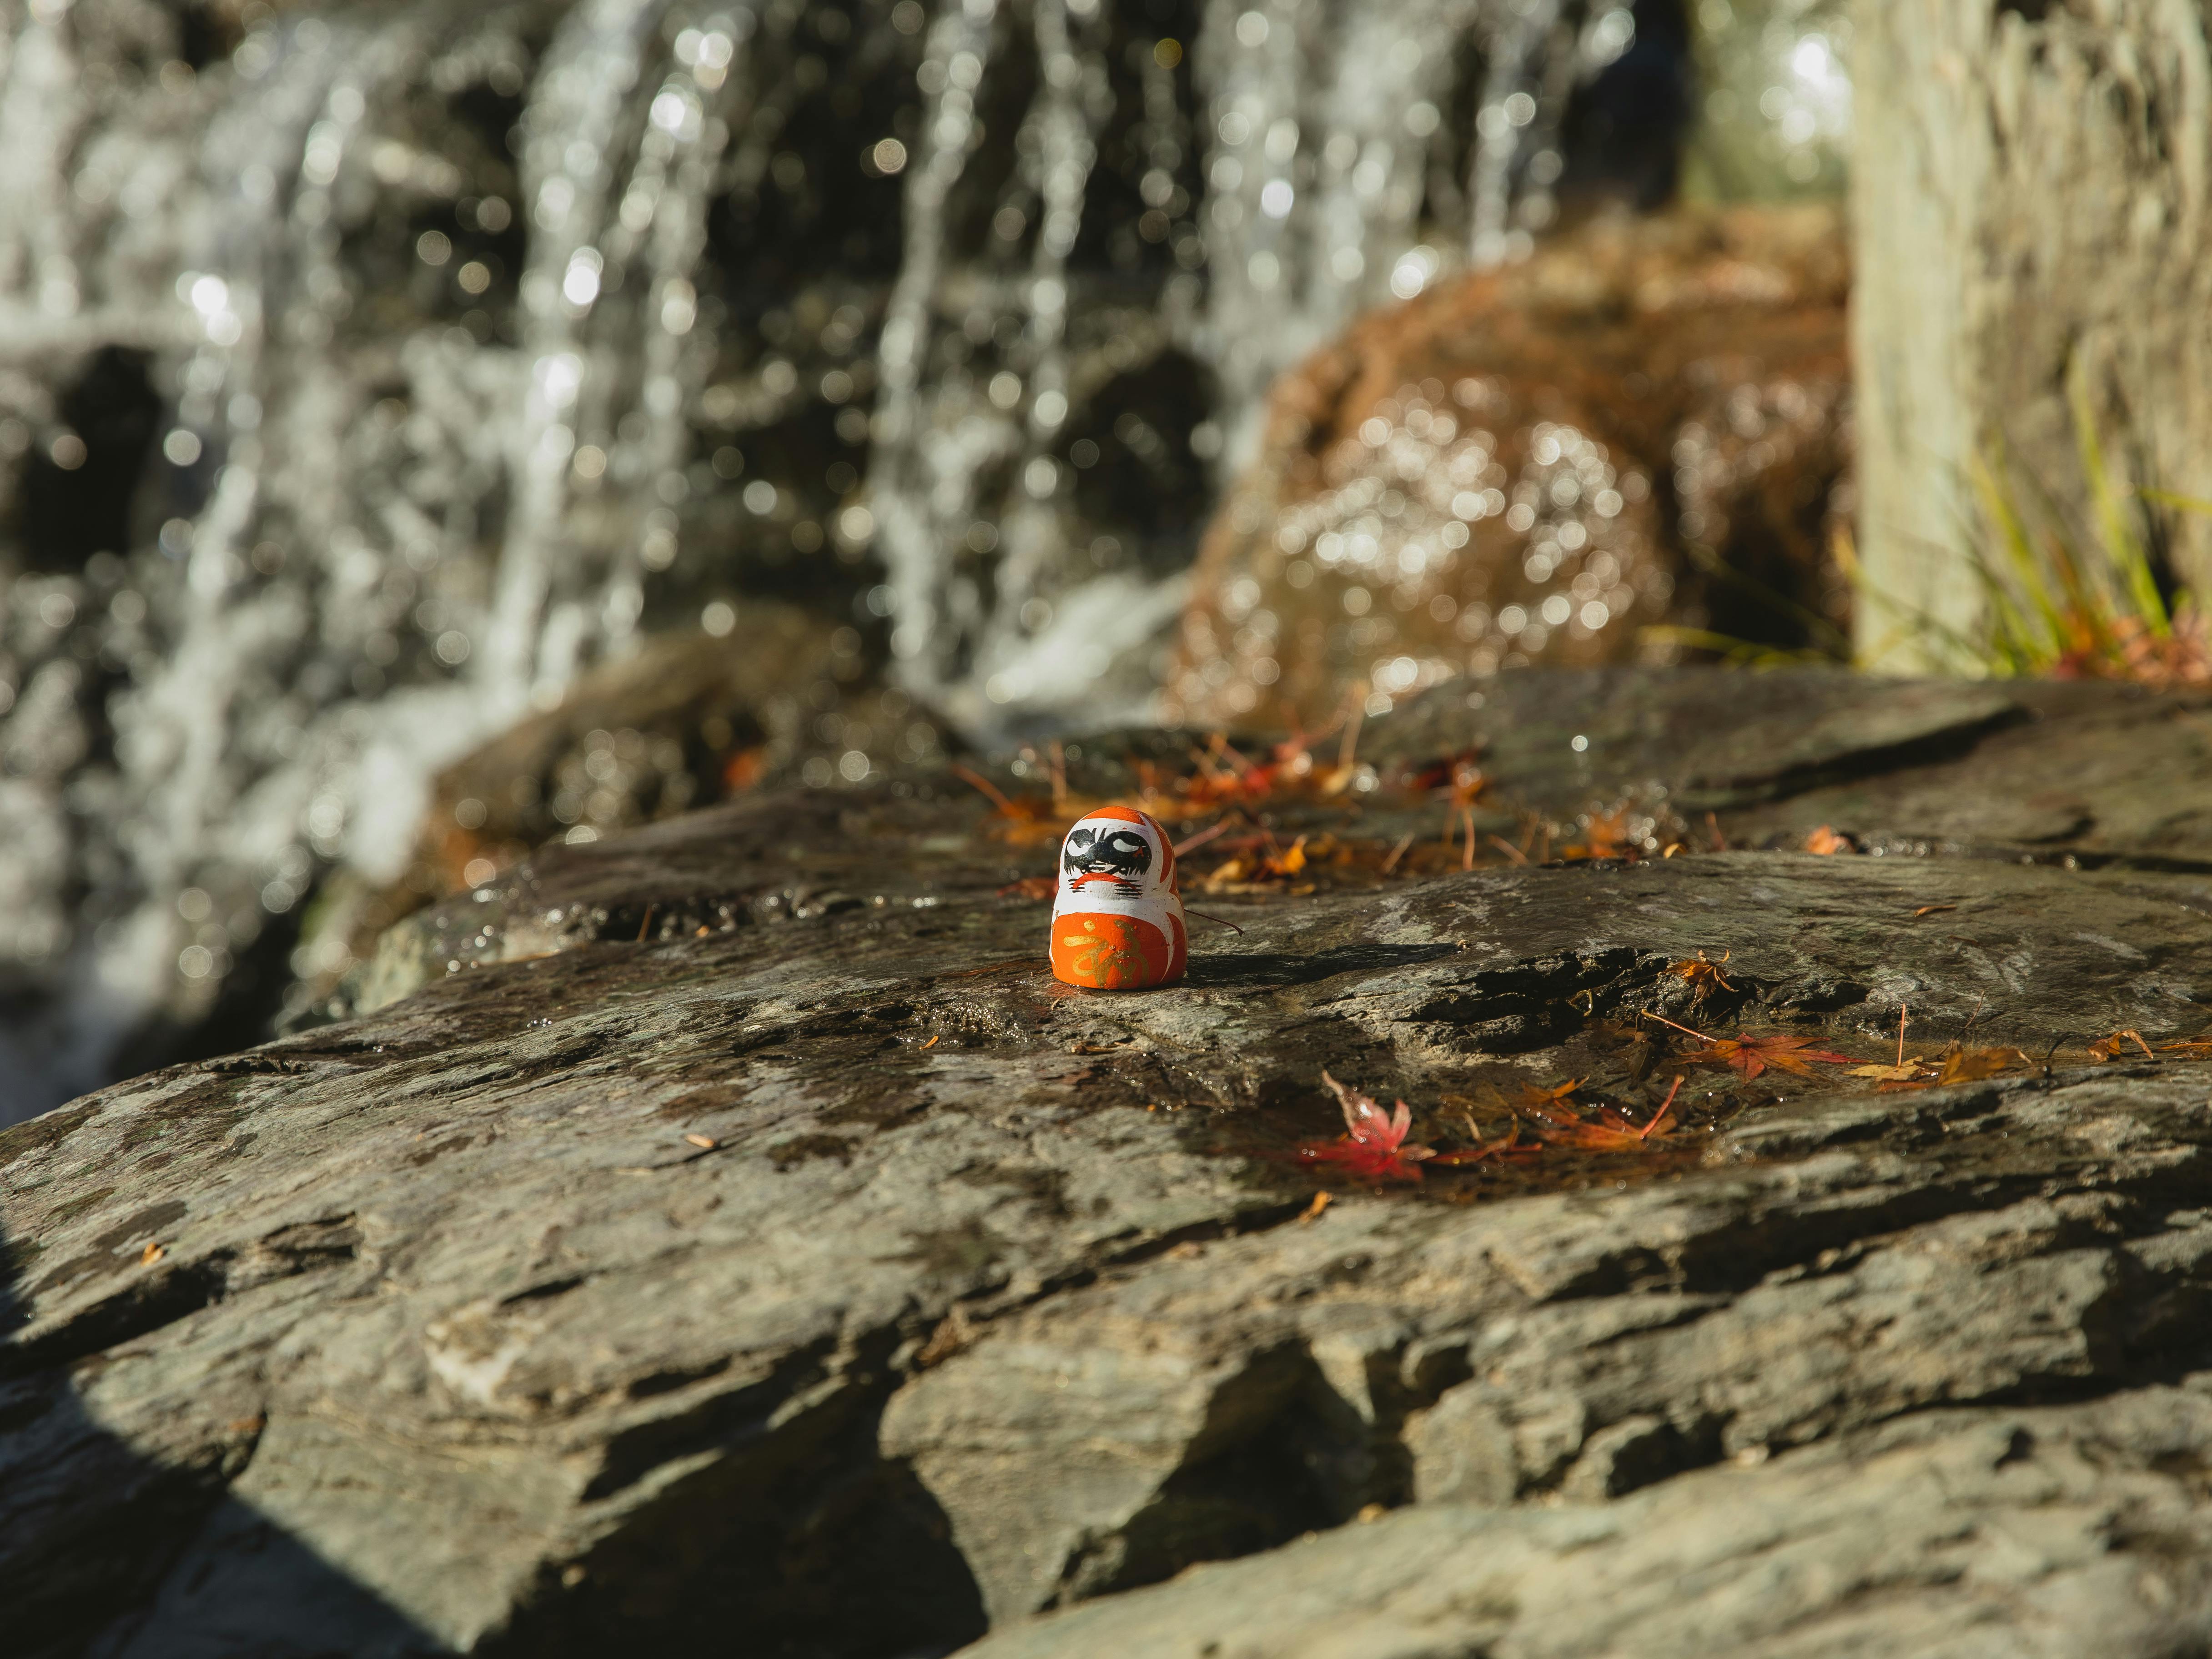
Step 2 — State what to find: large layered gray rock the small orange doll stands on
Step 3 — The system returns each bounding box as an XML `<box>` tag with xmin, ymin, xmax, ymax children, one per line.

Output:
<box><xmin>0</xmin><ymin>670</ymin><xmax>2212</xmax><ymax>1659</ymax></box>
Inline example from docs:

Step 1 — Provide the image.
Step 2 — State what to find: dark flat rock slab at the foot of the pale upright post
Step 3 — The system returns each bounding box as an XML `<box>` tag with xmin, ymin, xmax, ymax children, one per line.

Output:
<box><xmin>1380</xmin><ymin>668</ymin><xmax>2212</xmax><ymax>865</ymax></box>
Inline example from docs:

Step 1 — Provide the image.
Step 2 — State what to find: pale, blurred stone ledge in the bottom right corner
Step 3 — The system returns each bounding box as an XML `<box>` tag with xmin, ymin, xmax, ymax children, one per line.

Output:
<box><xmin>969</xmin><ymin>1387</ymin><xmax>2212</xmax><ymax>1659</ymax></box>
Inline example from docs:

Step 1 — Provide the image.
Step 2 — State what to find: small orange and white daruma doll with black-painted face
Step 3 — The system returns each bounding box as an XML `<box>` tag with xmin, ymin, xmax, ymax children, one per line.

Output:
<box><xmin>1053</xmin><ymin>807</ymin><xmax>1183</xmax><ymax>991</ymax></box>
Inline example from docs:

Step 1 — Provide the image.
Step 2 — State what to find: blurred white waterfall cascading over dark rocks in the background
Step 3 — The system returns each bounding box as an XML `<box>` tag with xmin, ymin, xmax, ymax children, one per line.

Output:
<box><xmin>0</xmin><ymin>0</ymin><xmax>1663</xmax><ymax>1121</ymax></box>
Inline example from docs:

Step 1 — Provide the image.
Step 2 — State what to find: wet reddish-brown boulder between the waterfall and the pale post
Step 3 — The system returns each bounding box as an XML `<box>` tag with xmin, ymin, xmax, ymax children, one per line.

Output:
<box><xmin>1163</xmin><ymin>206</ymin><xmax>1849</xmax><ymax>724</ymax></box>
